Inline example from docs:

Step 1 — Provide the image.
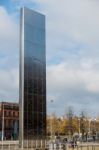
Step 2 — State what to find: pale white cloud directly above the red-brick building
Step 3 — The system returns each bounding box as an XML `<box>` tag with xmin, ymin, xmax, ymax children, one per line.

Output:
<box><xmin>0</xmin><ymin>69</ymin><xmax>19</xmax><ymax>101</ymax></box>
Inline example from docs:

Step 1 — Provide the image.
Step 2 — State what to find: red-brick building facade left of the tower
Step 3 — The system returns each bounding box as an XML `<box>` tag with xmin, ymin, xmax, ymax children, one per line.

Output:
<box><xmin>0</xmin><ymin>102</ymin><xmax>19</xmax><ymax>140</ymax></box>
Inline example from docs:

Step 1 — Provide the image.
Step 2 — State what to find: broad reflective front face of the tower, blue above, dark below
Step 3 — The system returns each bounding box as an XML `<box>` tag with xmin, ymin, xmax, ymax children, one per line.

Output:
<box><xmin>21</xmin><ymin>8</ymin><xmax>46</xmax><ymax>142</ymax></box>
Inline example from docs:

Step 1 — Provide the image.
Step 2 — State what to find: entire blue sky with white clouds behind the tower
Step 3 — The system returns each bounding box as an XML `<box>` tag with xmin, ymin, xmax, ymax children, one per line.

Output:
<box><xmin>0</xmin><ymin>0</ymin><xmax>99</xmax><ymax>116</ymax></box>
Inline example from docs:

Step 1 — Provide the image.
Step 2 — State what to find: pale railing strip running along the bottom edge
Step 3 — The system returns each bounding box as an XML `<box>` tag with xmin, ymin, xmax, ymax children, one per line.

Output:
<box><xmin>0</xmin><ymin>140</ymin><xmax>99</xmax><ymax>150</ymax></box>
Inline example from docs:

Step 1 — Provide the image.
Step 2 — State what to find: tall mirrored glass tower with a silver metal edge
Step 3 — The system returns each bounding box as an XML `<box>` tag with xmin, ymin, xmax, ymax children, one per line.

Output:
<box><xmin>19</xmin><ymin>8</ymin><xmax>46</xmax><ymax>147</ymax></box>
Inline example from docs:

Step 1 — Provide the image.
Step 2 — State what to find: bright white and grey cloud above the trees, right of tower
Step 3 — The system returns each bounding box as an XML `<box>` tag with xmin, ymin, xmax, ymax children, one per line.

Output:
<box><xmin>47</xmin><ymin>59</ymin><xmax>99</xmax><ymax>115</ymax></box>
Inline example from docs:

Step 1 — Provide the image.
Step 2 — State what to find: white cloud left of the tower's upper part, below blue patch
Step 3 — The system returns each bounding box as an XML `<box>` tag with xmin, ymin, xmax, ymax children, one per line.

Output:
<box><xmin>0</xmin><ymin>7</ymin><xmax>19</xmax><ymax>55</ymax></box>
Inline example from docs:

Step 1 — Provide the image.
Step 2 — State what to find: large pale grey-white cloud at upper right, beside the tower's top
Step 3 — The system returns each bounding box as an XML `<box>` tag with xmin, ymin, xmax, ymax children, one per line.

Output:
<box><xmin>32</xmin><ymin>0</ymin><xmax>99</xmax><ymax>59</ymax></box>
